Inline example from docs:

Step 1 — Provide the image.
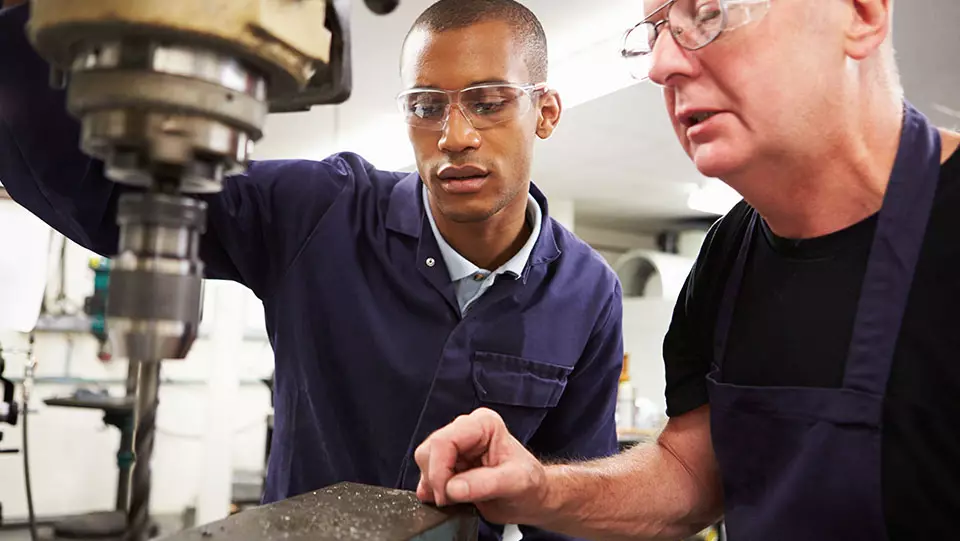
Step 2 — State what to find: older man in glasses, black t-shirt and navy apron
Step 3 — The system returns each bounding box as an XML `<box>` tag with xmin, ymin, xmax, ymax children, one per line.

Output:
<box><xmin>417</xmin><ymin>0</ymin><xmax>960</xmax><ymax>541</ymax></box>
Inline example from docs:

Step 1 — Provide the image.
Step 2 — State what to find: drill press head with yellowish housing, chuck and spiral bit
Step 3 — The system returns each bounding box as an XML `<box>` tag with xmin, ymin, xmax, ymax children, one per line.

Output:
<box><xmin>15</xmin><ymin>0</ymin><xmax>398</xmax><ymax>541</ymax></box>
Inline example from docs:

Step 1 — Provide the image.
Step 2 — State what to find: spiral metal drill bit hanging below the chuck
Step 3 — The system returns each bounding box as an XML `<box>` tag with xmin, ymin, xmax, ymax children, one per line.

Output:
<box><xmin>126</xmin><ymin>361</ymin><xmax>160</xmax><ymax>541</ymax></box>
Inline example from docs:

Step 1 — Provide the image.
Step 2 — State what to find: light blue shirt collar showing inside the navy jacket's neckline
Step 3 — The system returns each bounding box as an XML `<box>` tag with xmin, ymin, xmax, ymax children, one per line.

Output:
<box><xmin>421</xmin><ymin>186</ymin><xmax>543</xmax><ymax>314</ymax></box>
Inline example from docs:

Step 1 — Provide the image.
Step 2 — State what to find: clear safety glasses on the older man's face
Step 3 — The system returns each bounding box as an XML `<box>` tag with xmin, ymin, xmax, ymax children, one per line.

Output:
<box><xmin>620</xmin><ymin>0</ymin><xmax>770</xmax><ymax>81</ymax></box>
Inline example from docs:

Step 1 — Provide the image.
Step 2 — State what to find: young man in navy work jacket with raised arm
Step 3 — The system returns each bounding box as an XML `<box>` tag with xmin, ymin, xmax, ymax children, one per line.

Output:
<box><xmin>0</xmin><ymin>0</ymin><xmax>623</xmax><ymax>539</ymax></box>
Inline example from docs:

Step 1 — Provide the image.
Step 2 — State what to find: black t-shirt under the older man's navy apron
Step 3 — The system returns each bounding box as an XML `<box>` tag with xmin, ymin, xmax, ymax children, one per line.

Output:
<box><xmin>664</xmin><ymin>144</ymin><xmax>960</xmax><ymax>541</ymax></box>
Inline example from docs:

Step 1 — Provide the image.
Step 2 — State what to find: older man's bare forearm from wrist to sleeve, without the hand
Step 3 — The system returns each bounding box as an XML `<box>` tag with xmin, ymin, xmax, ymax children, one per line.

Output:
<box><xmin>544</xmin><ymin>406</ymin><xmax>723</xmax><ymax>540</ymax></box>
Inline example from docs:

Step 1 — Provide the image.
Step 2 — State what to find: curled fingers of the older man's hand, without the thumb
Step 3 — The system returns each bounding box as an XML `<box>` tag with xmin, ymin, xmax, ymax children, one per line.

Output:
<box><xmin>414</xmin><ymin>409</ymin><xmax>506</xmax><ymax>506</ymax></box>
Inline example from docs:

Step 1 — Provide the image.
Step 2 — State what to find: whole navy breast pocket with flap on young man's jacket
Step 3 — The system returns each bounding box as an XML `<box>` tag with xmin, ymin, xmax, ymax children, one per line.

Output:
<box><xmin>472</xmin><ymin>351</ymin><xmax>573</xmax><ymax>442</ymax></box>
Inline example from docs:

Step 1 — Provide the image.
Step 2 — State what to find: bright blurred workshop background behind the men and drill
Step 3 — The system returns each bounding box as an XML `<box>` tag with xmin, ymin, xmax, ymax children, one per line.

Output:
<box><xmin>0</xmin><ymin>0</ymin><xmax>960</xmax><ymax>539</ymax></box>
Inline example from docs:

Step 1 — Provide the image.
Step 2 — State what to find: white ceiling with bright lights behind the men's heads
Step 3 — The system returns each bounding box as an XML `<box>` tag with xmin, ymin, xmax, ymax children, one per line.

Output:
<box><xmin>249</xmin><ymin>0</ymin><xmax>960</xmax><ymax>233</ymax></box>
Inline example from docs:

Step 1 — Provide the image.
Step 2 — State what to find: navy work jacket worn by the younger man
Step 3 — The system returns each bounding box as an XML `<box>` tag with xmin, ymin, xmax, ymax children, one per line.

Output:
<box><xmin>0</xmin><ymin>3</ymin><xmax>623</xmax><ymax>539</ymax></box>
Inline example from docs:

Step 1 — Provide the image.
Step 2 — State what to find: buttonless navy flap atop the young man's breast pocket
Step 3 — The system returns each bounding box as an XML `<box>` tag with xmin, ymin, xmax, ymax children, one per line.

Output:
<box><xmin>473</xmin><ymin>351</ymin><xmax>573</xmax><ymax>408</ymax></box>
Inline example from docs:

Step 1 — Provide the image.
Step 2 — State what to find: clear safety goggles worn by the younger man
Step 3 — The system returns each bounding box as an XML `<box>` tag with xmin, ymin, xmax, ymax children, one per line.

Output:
<box><xmin>397</xmin><ymin>83</ymin><xmax>546</xmax><ymax>131</ymax></box>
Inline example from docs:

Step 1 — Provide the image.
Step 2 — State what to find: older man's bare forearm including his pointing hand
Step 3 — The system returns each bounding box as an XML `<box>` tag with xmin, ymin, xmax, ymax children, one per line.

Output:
<box><xmin>416</xmin><ymin>406</ymin><xmax>723</xmax><ymax>541</ymax></box>
